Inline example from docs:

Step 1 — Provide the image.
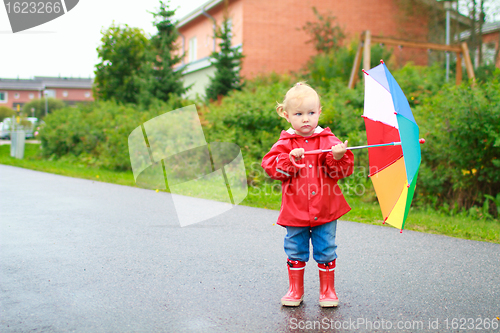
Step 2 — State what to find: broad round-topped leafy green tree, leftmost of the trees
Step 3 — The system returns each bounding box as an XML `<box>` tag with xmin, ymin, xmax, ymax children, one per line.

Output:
<box><xmin>93</xmin><ymin>23</ymin><xmax>149</xmax><ymax>103</ymax></box>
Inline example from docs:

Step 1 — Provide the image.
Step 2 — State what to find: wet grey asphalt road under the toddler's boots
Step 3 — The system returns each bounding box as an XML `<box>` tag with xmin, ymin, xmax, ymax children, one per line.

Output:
<box><xmin>0</xmin><ymin>165</ymin><xmax>500</xmax><ymax>332</ymax></box>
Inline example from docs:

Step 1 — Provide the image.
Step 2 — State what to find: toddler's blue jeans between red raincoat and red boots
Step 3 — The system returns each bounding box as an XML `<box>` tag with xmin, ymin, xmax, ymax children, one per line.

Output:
<box><xmin>285</xmin><ymin>220</ymin><xmax>337</xmax><ymax>264</ymax></box>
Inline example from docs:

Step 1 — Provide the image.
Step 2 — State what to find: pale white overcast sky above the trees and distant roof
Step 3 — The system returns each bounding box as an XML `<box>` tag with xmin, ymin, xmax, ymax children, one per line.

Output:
<box><xmin>0</xmin><ymin>0</ymin><xmax>207</xmax><ymax>79</ymax></box>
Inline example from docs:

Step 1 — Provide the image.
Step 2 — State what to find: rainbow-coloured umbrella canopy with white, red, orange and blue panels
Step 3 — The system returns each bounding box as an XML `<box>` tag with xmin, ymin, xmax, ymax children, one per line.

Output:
<box><xmin>363</xmin><ymin>62</ymin><xmax>420</xmax><ymax>230</ymax></box>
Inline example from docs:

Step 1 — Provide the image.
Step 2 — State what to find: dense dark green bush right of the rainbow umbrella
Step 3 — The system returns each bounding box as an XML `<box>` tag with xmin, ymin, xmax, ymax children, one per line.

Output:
<box><xmin>415</xmin><ymin>78</ymin><xmax>500</xmax><ymax>216</ymax></box>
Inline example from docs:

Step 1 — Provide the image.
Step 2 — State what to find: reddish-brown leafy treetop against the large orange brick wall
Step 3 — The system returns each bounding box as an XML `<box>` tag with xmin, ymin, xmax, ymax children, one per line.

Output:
<box><xmin>302</xmin><ymin>7</ymin><xmax>345</xmax><ymax>52</ymax></box>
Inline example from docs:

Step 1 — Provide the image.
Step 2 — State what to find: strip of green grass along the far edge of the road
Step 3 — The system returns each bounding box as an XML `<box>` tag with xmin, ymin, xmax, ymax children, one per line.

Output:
<box><xmin>0</xmin><ymin>144</ymin><xmax>500</xmax><ymax>243</ymax></box>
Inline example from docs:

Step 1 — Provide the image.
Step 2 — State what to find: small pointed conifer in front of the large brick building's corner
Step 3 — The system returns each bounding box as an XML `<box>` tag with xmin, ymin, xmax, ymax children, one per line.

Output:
<box><xmin>206</xmin><ymin>13</ymin><xmax>244</xmax><ymax>100</ymax></box>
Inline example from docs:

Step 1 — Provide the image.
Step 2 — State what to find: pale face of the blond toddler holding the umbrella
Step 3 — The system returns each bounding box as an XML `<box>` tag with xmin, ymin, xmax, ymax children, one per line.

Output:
<box><xmin>284</xmin><ymin>94</ymin><xmax>321</xmax><ymax>136</ymax></box>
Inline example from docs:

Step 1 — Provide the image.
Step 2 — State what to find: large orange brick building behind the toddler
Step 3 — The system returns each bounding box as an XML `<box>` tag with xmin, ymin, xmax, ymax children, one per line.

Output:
<box><xmin>177</xmin><ymin>0</ymin><xmax>450</xmax><ymax>96</ymax></box>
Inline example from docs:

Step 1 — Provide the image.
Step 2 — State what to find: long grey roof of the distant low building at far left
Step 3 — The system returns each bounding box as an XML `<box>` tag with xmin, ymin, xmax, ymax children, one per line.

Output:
<box><xmin>0</xmin><ymin>76</ymin><xmax>93</xmax><ymax>91</ymax></box>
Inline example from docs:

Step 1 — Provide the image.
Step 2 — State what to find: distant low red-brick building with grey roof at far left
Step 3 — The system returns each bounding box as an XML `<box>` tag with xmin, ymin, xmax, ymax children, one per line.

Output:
<box><xmin>0</xmin><ymin>76</ymin><xmax>94</xmax><ymax>109</ymax></box>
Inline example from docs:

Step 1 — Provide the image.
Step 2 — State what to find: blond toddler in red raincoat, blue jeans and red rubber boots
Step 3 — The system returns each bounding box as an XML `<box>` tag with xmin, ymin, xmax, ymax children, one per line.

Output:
<box><xmin>262</xmin><ymin>82</ymin><xmax>354</xmax><ymax>307</ymax></box>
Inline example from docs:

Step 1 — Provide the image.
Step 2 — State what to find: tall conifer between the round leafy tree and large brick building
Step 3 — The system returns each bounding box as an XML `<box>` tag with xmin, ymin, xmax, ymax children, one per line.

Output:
<box><xmin>140</xmin><ymin>1</ymin><xmax>186</xmax><ymax>104</ymax></box>
